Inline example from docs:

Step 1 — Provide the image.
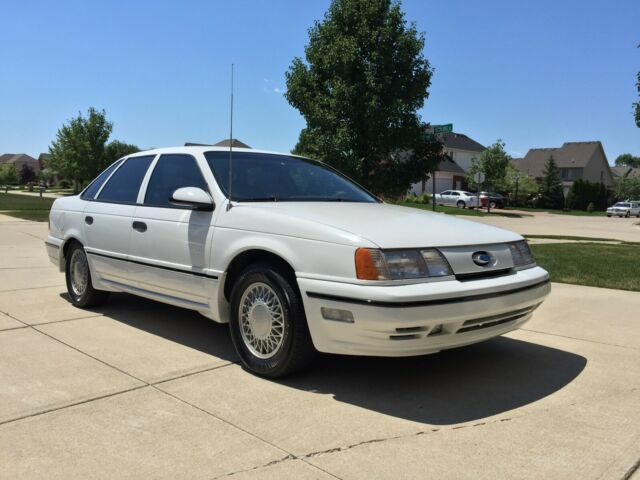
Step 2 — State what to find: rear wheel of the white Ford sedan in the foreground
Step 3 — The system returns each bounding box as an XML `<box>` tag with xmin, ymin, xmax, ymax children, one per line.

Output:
<box><xmin>65</xmin><ymin>241</ymin><xmax>109</xmax><ymax>308</ymax></box>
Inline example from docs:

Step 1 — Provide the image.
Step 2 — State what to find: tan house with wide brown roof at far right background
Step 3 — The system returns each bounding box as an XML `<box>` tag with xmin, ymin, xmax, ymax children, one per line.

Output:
<box><xmin>514</xmin><ymin>141</ymin><xmax>614</xmax><ymax>193</ymax></box>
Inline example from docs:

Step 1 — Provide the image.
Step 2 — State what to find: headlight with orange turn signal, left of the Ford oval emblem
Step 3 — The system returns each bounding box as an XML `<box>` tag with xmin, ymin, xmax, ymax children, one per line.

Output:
<box><xmin>356</xmin><ymin>248</ymin><xmax>453</xmax><ymax>280</ymax></box>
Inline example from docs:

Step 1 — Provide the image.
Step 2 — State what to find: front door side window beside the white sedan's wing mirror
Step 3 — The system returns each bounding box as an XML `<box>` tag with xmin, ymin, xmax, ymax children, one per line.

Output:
<box><xmin>144</xmin><ymin>154</ymin><xmax>207</xmax><ymax>207</ymax></box>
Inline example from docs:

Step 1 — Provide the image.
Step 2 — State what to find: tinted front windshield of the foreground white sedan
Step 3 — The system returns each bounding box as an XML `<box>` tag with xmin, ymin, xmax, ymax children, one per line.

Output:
<box><xmin>204</xmin><ymin>151</ymin><xmax>377</xmax><ymax>203</ymax></box>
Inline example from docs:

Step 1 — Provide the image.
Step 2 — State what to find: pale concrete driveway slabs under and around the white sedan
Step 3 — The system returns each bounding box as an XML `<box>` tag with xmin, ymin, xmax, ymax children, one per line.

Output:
<box><xmin>0</xmin><ymin>216</ymin><xmax>640</xmax><ymax>479</ymax></box>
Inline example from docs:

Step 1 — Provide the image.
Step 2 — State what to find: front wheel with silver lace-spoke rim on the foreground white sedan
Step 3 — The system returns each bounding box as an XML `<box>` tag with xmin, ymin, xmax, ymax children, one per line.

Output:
<box><xmin>229</xmin><ymin>265</ymin><xmax>316</xmax><ymax>377</ymax></box>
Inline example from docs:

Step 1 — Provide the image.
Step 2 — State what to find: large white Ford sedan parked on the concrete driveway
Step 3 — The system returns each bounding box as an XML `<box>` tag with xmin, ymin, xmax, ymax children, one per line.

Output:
<box><xmin>46</xmin><ymin>147</ymin><xmax>550</xmax><ymax>377</ymax></box>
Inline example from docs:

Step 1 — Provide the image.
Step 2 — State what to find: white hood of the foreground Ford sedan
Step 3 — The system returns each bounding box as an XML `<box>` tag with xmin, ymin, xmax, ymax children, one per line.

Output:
<box><xmin>225</xmin><ymin>202</ymin><xmax>522</xmax><ymax>248</ymax></box>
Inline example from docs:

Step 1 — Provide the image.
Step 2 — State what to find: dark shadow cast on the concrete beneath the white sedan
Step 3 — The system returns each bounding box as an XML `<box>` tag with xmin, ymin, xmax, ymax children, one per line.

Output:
<box><xmin>70</xmin><ymin>294</ymin><xmax>587</xmax><ymax>425</ymax></box>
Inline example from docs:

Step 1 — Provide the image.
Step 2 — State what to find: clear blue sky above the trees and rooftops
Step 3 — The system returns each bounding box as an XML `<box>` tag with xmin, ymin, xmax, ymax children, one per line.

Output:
<box><xmin>0</xmin><ymin>0</ymin><xmax>640</xmax><ymax>162</ymax></box>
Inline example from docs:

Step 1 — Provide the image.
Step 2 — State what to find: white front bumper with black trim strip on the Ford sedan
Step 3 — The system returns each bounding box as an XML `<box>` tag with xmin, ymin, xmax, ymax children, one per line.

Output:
<box><xmin>298</xmin><ymin>267</ymin><xmax>551</xmax><ymax>357</ymax></box>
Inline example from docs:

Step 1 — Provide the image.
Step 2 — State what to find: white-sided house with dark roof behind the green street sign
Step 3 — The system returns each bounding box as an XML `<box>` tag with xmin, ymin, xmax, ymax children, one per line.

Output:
<box><xmin>410</xmin><ymin>132</ymin><xmax>485</xmax><ymax>195</ymax></box>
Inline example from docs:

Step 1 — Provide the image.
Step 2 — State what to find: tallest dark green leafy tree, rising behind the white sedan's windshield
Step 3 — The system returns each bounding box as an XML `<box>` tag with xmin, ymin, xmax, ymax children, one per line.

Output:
<box><xmin>285</xmin><ymin>0</ymin><xmax>441</xmax><ymax>197</ymax></box>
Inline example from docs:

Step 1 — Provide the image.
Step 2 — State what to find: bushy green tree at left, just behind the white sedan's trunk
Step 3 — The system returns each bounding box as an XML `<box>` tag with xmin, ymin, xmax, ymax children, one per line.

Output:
<box><xmin>47</xmin><ymin>107</ymin><xmax>113</xmax><ymax>191</ymax></box>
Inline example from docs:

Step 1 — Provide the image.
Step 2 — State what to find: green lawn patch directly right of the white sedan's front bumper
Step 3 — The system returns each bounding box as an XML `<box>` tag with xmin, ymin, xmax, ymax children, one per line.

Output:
<box><xmin>531</xmin><ymin>244</ymin><xmax>640</xmax><ymax>292</ymax></box>
